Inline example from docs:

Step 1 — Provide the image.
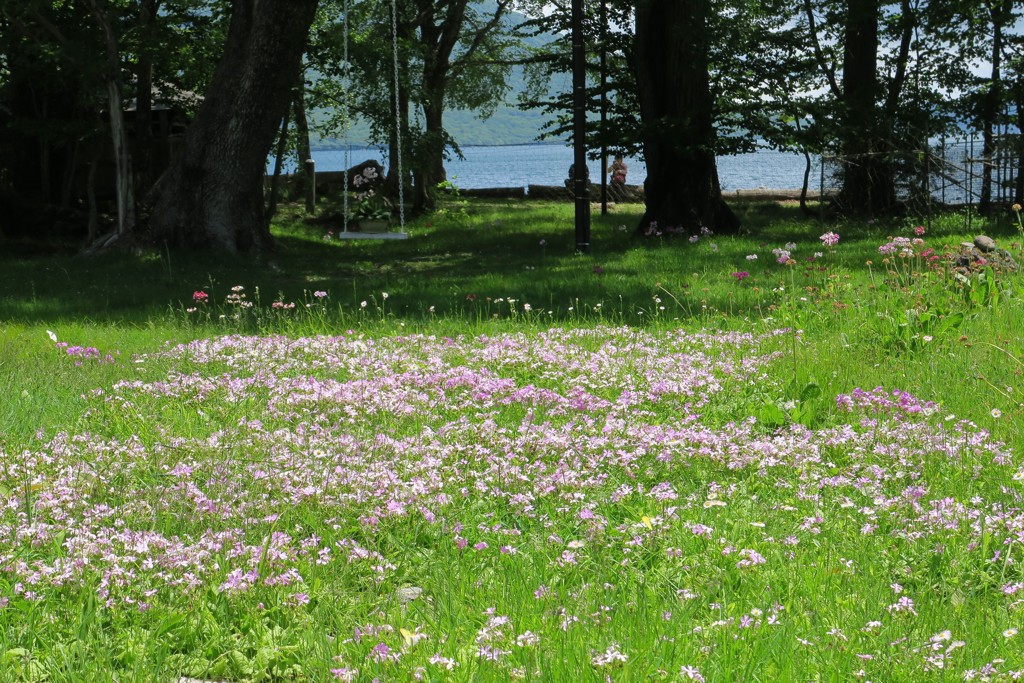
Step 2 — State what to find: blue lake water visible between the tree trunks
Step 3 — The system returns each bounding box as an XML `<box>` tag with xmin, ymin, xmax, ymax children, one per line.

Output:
<box><xmin>299</xmin><ymin>144</ymin><xmax>817</xmax><ymax>191</ymax></box>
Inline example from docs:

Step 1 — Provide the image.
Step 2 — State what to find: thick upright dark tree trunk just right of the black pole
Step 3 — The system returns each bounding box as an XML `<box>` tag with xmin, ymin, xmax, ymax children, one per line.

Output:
<box><xmin>635</xmin><ymin>0</ymin><xmax>739</xmax><ymax>234</ymax></box>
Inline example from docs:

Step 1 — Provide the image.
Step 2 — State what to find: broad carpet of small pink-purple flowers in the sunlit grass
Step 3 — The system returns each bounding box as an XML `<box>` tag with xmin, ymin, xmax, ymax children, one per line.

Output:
<box><xmin>0</xmin><ymin>328</ymin><xmax>1024</xmax><ymax>681</ymax></box>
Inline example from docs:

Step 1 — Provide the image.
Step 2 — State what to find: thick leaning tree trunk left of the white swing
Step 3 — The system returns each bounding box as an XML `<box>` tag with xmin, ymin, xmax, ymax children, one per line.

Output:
<box><xmin>150</xmin><ymin>0</ymin><xmax>317</xmax><ymax>253</ymax></box>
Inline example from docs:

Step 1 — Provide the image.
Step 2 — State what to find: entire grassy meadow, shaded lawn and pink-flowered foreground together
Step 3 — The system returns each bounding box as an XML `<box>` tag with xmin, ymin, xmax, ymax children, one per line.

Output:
<box><xmin>0</xmin><ymin>201</ymin><xmax>1024</xmax><ymax>682</ymax></box>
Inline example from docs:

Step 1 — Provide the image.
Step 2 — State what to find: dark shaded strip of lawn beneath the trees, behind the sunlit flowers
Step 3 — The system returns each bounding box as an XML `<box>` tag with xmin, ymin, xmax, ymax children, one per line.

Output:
<box><xmin>0</xmin><ymin>201</ymin><xmax>1011</xmax><ymax>325</ymax></box>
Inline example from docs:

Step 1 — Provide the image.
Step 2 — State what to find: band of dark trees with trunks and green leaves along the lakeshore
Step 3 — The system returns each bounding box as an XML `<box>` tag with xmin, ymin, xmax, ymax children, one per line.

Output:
<box><xmin>0</xmin><ymin>0</ymin><xmax>1024</xmax><ymax>251</ymax></box>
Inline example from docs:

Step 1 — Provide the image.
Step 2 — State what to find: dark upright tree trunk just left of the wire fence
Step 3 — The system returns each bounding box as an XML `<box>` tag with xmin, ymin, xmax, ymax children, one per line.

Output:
<box><xmin>840</xmin><ymin>0</ymin><xmax>896</xmax><ymax>216</ymax></box>
